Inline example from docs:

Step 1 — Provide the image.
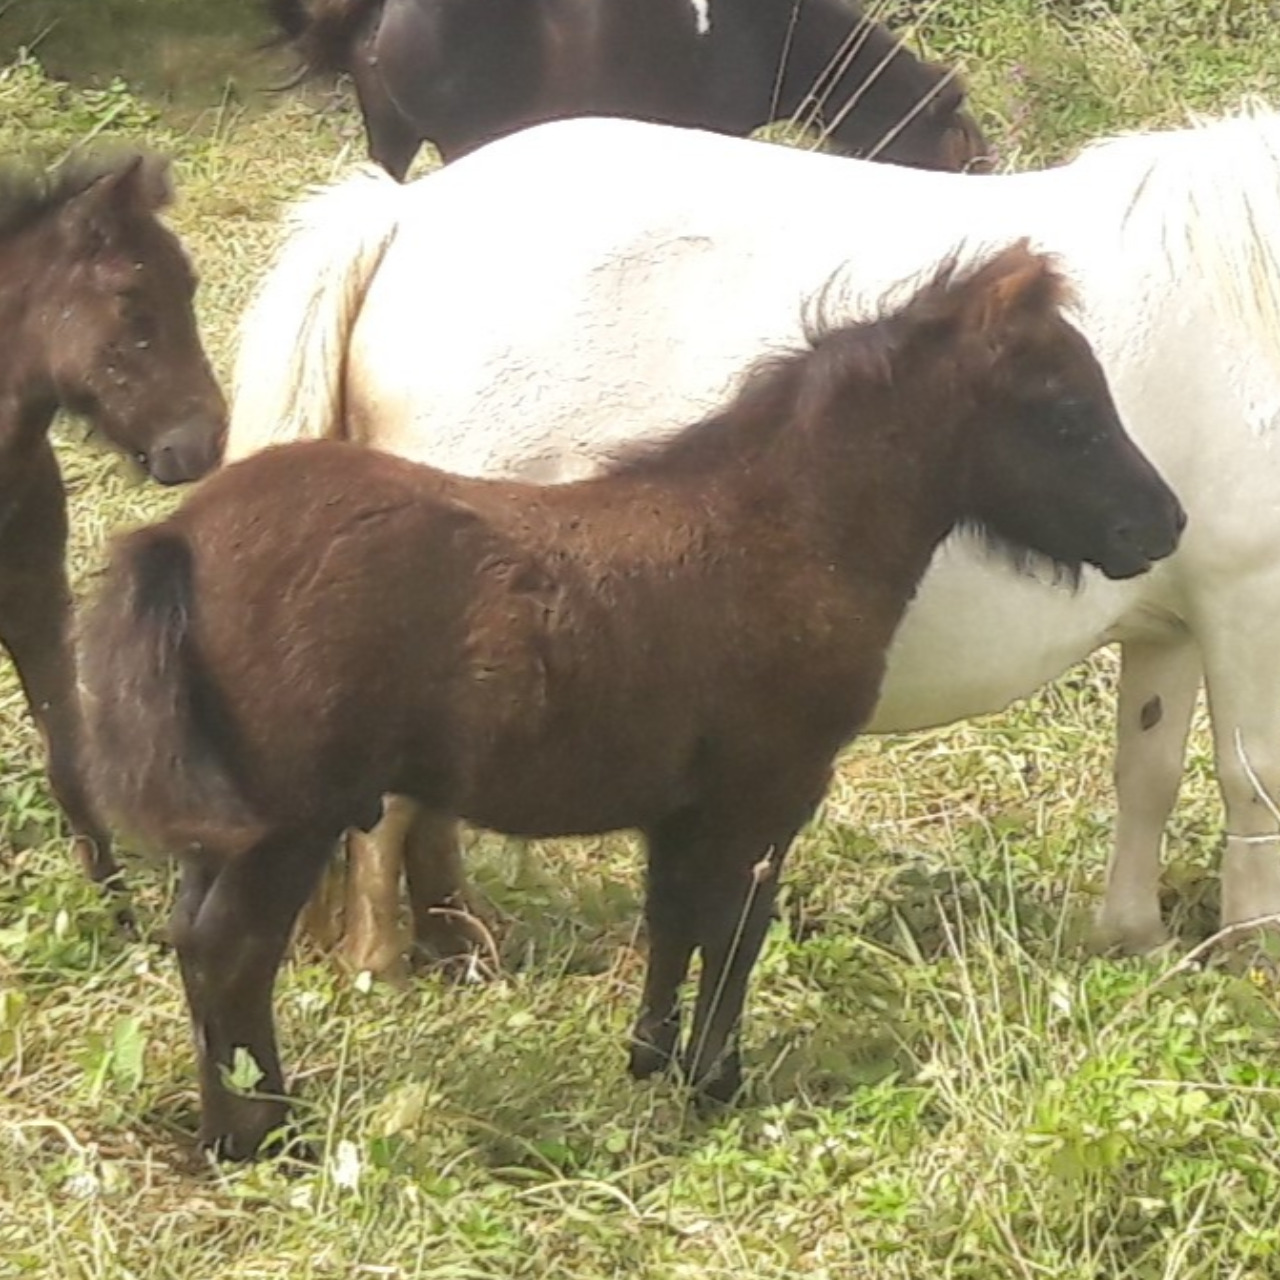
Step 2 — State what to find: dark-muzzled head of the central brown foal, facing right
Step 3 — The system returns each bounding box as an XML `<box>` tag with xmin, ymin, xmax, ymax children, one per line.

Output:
<box><xmin>885</xmin><ymin>241</ymin><xmax>1187</xmax><ymax>579</ymax></box>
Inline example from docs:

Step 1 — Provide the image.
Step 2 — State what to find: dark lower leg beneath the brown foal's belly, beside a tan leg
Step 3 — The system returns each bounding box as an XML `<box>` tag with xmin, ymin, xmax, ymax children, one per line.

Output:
<box><xmin>397</xmin><ymin>797</ymin><xmax>486</xmax><ymax>960</ymax></box>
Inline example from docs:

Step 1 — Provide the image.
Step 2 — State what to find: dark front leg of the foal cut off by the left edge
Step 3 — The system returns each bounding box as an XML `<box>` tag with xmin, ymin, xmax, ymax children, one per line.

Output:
<box><xmin>0</xmin><ymin>439</ymin><xmax>129</xmax><ymax>922</ymax></box>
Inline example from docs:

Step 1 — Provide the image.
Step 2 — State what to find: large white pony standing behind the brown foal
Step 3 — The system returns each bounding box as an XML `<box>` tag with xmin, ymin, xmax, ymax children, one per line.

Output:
<box><xmin>228</xmin><ymin>111</ymin><xmax>1280</xmax><ymax>967</ymax></box>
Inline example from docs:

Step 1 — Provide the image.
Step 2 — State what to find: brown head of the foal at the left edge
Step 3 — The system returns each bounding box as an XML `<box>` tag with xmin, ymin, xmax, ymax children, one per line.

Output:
<box><xmin>16</xmin><ymin>156</ymin><xmax>227</xmax><ymax>484</ymax></box>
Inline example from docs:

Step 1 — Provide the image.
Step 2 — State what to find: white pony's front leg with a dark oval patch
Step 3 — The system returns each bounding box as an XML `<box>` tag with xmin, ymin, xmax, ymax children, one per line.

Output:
<box><xmin>1097</xmin><ymin>637</ymin><xmax>1201</xmax><ymax>952</ymax></box>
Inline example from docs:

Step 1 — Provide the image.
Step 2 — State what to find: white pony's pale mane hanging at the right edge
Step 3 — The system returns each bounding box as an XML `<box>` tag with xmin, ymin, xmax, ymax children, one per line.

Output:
<box><xmin>1073</xmin><ymin>100</ymin><xmax>1280</xmax><ymax>361</ymax></box>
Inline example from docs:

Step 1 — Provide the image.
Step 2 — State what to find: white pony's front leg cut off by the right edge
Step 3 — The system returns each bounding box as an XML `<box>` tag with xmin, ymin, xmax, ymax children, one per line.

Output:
<box><xmin>1204</xmin><ymin>613</ymin><xmax>1280</xmax><ymax>924</ymax></box>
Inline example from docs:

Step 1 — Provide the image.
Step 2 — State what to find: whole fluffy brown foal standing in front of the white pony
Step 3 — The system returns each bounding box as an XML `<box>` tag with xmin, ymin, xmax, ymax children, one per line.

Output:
<box><xmin>82</xmin><ymin>246</ymin><xmax>1183</xmax><ymax>1156</ymax></box>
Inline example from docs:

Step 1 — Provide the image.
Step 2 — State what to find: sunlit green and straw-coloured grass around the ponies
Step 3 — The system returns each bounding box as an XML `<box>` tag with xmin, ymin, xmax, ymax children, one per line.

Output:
<box><xmin>0</xmin><ymin>0</ymin><xmax>1280</xmax><ymax>1280</ymax></box>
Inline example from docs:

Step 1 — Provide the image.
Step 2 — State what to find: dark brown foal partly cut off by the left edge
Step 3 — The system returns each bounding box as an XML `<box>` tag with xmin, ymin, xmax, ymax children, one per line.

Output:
<box><xmin>0</xmin><ymin>149</ymin><xmax>227</xmax><ymax>906</ymax></box>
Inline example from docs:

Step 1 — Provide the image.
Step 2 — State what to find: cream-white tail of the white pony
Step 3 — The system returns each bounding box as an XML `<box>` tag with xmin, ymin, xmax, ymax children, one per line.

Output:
<box><xmin>223</xmin><ymin>165</ymin><xmax>407</xmax><ymax>462</ymax></box>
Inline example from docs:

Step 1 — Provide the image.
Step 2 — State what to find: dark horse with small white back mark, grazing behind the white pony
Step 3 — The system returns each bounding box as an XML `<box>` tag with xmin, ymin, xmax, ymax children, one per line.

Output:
<box><xmin>268</xmin><ymin>0</ymin><xmax>987</xmax><ymax>179</ymax></box>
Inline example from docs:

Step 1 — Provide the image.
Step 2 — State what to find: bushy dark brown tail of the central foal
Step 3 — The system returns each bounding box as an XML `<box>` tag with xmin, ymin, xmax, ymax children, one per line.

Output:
<box><xmin>79</xmin><ymin>525</ymin><xmax>265</xmax><ymax>856</ymax></box>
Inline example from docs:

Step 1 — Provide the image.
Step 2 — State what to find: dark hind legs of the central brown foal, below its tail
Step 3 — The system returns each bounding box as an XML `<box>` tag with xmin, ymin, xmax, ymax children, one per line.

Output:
<box><xmin>173</xmin><ymin>832</ymin><xmax>338</xmax><ymax>1160</ymax></box>
